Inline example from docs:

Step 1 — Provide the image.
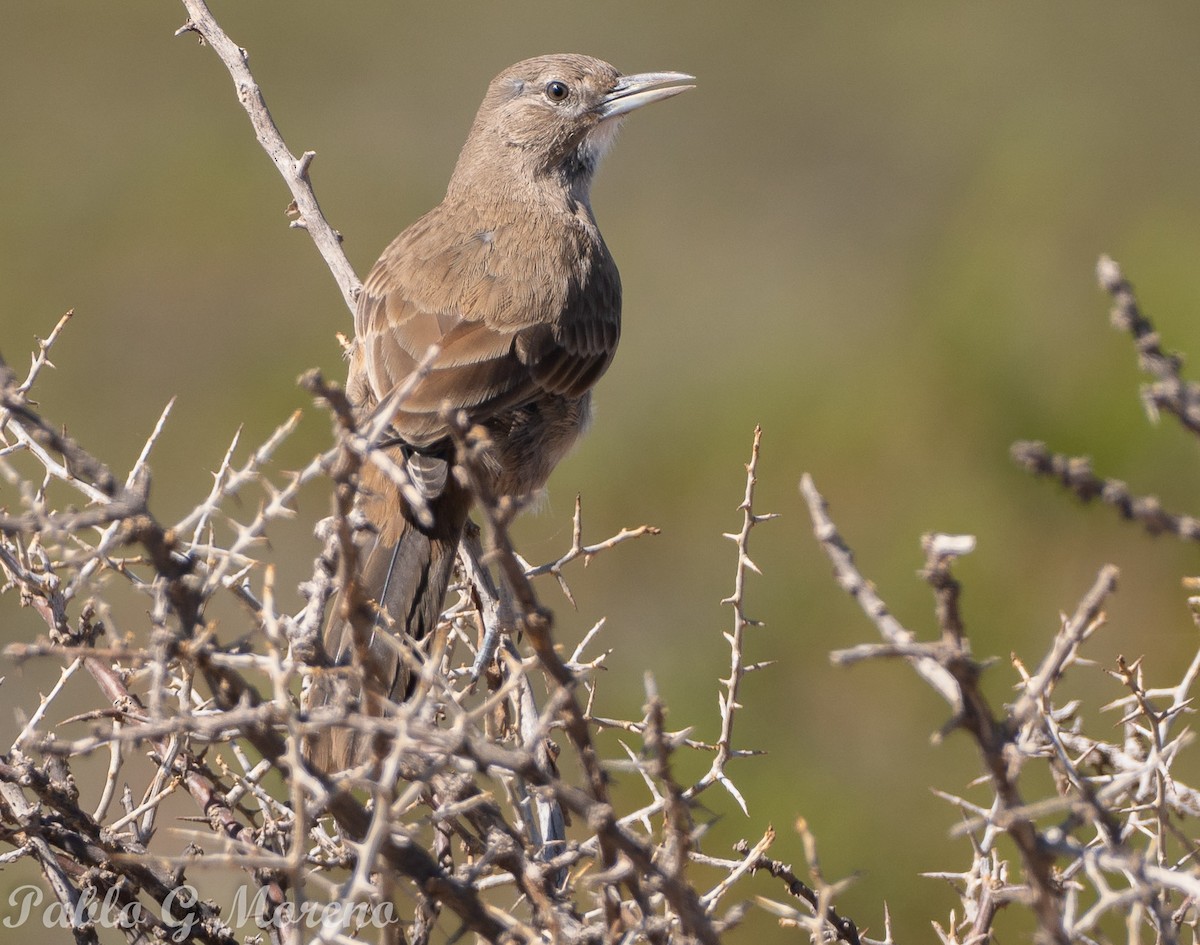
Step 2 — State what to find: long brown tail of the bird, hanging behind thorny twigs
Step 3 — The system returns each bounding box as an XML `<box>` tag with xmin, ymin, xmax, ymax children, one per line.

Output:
<box><xmin>305</xmin><ymin>467</ymin><xmax>470</xmax><ymax>772</ymax></box>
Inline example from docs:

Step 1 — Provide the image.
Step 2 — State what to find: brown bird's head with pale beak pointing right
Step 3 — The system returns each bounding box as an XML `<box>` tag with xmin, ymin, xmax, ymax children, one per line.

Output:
<box><xmin>455</xmin><ymin>54</ymin><xmax>694</xmax><ymax>197</ymax></box>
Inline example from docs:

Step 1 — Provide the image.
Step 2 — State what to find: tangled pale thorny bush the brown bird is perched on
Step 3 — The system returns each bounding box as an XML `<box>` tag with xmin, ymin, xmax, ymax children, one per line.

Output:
<box><xmin>0</xmin><ymin>0</ymin><xmax>835</xmax><ymax>945</ymax></box>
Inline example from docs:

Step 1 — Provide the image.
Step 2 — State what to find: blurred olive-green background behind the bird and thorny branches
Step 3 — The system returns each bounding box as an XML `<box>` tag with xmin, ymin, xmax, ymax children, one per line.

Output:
<box><xmin>0</xmin><ymin>0</ymin><xmax>1200</xmax><ymax>941</ymax></box>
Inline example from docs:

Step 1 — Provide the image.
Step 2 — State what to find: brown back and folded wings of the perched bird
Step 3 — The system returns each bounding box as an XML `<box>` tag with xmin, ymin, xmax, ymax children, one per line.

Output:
<box><xmin>355</xmin><ymin>205</ymin><xmax>620</xmax><ymax>446</ymax></box>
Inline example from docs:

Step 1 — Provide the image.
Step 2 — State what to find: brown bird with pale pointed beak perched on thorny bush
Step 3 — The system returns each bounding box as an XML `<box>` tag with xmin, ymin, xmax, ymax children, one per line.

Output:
<box><xmin>308</xmin><ymin>55</ymin><xmax>692</xmax><ymax>770</ymax></box>
